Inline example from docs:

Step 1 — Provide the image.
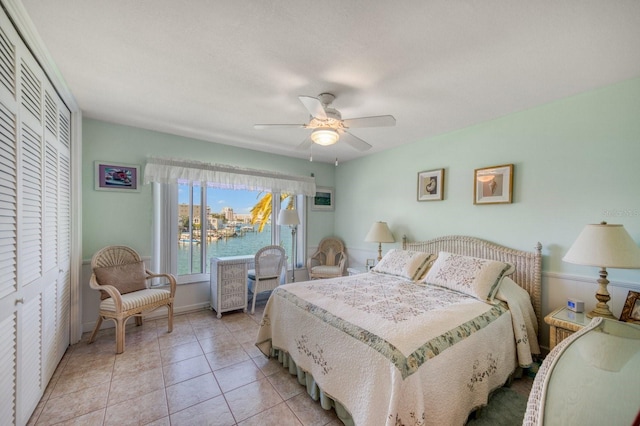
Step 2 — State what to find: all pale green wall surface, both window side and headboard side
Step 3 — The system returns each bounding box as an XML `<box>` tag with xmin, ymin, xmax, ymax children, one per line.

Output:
<box><xmin>83</xmin><ymin>74</ymin><xmax>640</xmax><ymax>283</ymax></box>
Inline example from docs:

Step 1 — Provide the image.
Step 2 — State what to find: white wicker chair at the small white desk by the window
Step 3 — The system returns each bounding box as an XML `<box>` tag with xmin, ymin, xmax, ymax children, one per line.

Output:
<box><xmin>249</xmin><ymin>245</ymin><xmax>286</xmax><ymax>314</ymax></box>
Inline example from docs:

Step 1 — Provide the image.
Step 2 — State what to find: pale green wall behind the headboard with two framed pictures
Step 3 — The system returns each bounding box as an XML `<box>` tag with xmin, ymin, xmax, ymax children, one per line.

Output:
<box><xmin>335</xmin><ymin>78</ymin><xmax>640</xmax><ymax>283</ymax></box>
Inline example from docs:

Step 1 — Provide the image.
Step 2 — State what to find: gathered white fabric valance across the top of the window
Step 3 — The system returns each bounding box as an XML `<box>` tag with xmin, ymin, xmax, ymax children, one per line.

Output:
<box><xmin>144</xmin><ymin>158</ymin><xmax>316</xmax><ymax>196</ymax></box>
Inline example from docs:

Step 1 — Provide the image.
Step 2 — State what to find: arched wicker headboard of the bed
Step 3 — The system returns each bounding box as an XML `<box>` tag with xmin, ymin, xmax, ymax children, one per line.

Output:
<box><xmin>402</xmin><ymin>235</ymin><xmax>542</xmax><ymax>334</ymax></box>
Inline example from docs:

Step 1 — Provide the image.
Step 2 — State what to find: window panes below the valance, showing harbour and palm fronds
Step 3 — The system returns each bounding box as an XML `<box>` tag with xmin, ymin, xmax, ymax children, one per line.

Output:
<box><xmin>155</xmin><ymin>181</ymin><xmax>305</xmax><ymax>283</ymax></box>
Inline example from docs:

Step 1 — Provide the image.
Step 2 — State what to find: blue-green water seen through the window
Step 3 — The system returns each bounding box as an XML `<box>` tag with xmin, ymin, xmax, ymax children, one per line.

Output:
<box><xmin>178</xmin><ymin>225</ymin><xmax>291</xmax><ymax>275</ymax></box>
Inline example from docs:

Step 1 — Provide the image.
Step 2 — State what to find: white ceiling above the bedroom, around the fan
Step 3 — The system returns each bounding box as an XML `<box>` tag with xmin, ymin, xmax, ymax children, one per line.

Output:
<box><xmin>22</xmin><ymin>0</ymin><xmax>640</xmax><ymax>162</ymax></box>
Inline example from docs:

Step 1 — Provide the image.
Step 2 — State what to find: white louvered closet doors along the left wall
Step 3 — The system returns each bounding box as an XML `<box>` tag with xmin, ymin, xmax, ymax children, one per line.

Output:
<box><xmin>0</xmin><ymin>7</ymin><xmax>71</xmax><ymax>425</ymax></box>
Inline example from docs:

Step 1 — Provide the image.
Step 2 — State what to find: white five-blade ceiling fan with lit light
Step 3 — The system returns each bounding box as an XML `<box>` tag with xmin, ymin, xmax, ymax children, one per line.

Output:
<box><xmin>253</xmin><ymin>93</ymin><xmax>396</xmax><ymax>151</ymax></box>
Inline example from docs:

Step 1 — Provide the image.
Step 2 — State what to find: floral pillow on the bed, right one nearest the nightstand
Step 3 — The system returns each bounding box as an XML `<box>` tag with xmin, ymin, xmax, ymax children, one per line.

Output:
<box><xmin>424</xmin><ymin>252</ymin><xmax>515</xmax><ymax>301</ymax></box>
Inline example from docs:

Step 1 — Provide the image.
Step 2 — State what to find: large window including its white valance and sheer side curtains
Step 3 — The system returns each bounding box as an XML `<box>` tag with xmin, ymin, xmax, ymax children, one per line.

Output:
<box><xmin>144</xmin><ymin>158</ymin><xmax>316</xmax><ymax>283</ymax></box>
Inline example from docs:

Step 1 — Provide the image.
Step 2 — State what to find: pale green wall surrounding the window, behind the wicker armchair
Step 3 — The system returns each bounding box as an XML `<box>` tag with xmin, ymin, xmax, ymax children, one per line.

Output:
<box><xmin>82</xmin><ymin>119</ymin><xmax>335</xmax><ymax>259</ymax></box>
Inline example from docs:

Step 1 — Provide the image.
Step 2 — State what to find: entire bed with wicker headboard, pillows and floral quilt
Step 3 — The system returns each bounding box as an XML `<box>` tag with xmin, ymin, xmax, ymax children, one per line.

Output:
<box><xmin>256</xmin><ymin>236</ymin><xmax>541</xmax><ymax>426</ymax></box>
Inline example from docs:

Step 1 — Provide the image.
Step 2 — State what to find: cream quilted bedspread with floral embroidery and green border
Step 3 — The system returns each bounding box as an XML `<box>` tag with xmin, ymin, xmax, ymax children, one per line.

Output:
<box><xmin>256</xmin><ymin>273</ymin><xmax>530</xmax><ymax>426</ymax></box>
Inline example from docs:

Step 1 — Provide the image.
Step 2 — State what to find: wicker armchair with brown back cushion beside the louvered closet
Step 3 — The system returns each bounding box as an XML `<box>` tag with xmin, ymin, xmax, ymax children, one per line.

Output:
<box><xmin>89</xmin><ymin>246</ymin><xmax>176</xmax><ymax>354</ymax></box>
